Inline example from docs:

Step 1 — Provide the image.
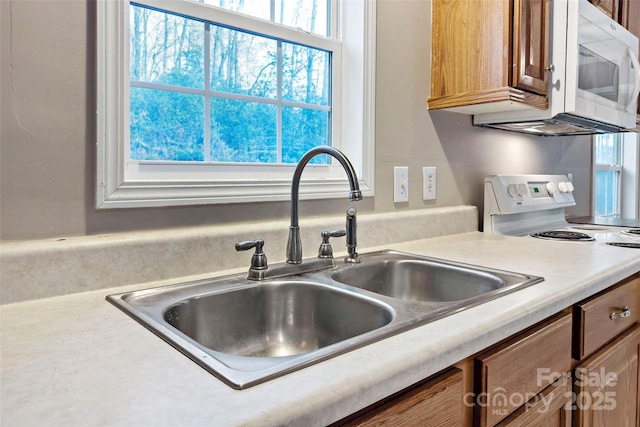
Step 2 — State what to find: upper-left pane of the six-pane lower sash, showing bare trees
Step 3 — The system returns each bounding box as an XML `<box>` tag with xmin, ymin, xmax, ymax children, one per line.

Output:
<box><xmin>129</xmin><ymin>6</ymin><xmax>204</xmax><ymax>88</ymax></box>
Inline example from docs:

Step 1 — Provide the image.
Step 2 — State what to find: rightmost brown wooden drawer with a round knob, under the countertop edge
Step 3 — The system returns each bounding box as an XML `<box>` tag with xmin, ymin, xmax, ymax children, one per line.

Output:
<box><xmin>574</xmin><ymin>273</ymin><xmax>640</xmax><ymax>360</ymax></box>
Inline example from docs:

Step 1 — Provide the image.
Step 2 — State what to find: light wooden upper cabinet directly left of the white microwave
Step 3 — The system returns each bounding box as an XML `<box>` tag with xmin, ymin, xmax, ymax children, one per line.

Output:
<box><xmin>428</xmin><ymin>0</ymin><xmax>550</xmax><ymax>114</ymax></box>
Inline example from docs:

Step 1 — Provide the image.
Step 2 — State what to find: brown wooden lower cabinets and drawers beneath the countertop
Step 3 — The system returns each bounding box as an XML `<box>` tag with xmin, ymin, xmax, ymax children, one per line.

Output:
<box><xmin>334</xmin><ymin>272</ymin><xmax>640</xmax><ymax>427</ymax></box>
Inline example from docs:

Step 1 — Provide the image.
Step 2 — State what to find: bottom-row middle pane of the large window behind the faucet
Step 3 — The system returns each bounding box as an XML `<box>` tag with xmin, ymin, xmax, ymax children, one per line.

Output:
<box><xmin>211</xmin><ymin>98</ymin><xmax>278</xmax><ymax>163</ymax></box>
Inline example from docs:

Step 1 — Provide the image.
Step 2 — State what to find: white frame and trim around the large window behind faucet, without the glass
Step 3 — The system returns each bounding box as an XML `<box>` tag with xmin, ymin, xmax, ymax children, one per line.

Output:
<box><xmin>96</xmin><ymin>0</ymin><xmax>376</xmax><ymax>209</ymax></box>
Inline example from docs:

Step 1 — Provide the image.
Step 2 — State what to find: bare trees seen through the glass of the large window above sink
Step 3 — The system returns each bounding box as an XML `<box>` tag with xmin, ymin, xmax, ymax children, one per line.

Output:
<box><xmin>129</xmin><ymin>0</ymin><xmax>332</xmax><ymax>163</ymax></box>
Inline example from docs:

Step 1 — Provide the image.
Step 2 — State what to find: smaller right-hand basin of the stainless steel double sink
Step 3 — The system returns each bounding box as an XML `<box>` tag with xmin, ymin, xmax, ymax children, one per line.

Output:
<box><xmin>331</xmin><ymin>259</ymin><xmax>508</xmax><ymax>302</ymax></box>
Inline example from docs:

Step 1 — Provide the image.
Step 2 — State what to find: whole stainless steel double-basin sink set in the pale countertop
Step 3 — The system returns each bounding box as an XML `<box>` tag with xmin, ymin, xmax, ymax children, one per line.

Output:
<box><xmin>107</xmin><ymin>251</ymin><xmax>543</xmax><ymax>389</ymax></box>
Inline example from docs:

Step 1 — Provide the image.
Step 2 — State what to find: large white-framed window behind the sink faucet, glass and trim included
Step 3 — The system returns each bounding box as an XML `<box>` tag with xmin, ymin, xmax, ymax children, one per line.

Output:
<box><xmin>96</xmin><ymin>0</ymin><xmax>375</xmax><ymax>208</ymax></box>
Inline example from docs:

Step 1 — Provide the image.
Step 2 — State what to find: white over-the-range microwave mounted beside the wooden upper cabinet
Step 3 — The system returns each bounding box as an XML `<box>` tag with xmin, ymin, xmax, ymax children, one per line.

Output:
<box><xmin>473</xmin><ymin>0</ymin><xmax>640</xmax><ymax>136</ymax></box>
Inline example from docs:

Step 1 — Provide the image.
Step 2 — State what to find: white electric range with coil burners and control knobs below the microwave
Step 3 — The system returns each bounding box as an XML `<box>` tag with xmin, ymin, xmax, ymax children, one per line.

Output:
<box><xmin>483</xmin><ymin>175</ymin><xmax>640</xmax><ymax>249</ymax></box>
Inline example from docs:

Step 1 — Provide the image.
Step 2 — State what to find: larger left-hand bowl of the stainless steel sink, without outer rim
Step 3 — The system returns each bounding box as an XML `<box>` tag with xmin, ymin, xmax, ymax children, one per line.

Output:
<box><xmin>164</xmin><ymin>282</ymin><xmax>393</xmax><ymax>357</ymax></box>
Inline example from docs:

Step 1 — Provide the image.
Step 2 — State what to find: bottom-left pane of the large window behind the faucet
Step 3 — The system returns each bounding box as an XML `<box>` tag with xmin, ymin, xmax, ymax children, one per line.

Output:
<box><xmin>130</xmin><ymin>87</ymin><xmax>204</xmax><ymax>161</ymax></box>
